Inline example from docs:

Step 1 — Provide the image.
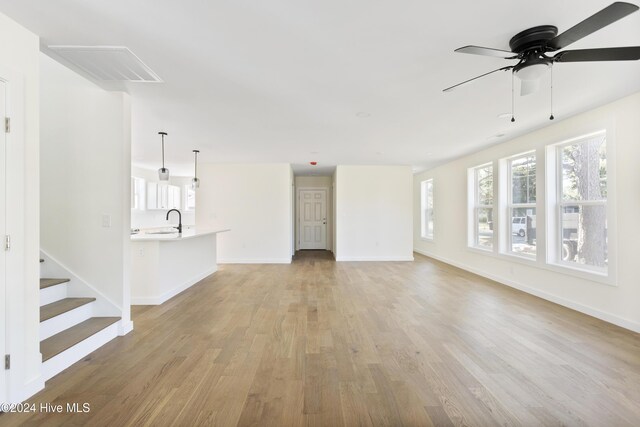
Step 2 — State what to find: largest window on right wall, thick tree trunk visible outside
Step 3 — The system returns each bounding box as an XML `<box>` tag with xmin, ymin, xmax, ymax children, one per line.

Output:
<box><xmin>552</xmin><ymin>132</ymin><xmax>609</xmax><ymax>273</ymax></box>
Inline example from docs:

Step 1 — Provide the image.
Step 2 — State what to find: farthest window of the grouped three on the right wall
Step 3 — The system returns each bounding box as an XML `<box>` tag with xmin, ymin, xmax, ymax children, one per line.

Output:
<box><xmin>470</xmin><ymin>164</ymin><xmax>495</xmax><ymax>251</ymax></box>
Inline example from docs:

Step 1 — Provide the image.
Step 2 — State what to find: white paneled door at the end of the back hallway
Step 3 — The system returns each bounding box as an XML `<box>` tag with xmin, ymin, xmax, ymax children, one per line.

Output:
<box><xmin>298</xmin><ymin>190</ymin><xmax>327</xmax><ymax>249</ymax></box>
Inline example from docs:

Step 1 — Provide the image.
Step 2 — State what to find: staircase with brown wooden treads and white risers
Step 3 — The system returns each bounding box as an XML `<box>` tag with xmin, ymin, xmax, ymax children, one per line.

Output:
<box><xmin>40</xmin><ymin>259</ymin><xmax>120</xmax><ymax>381</ymax></box>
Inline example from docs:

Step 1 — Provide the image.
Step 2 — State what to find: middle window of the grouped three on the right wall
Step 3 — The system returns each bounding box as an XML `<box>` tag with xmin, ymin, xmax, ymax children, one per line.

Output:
<box><xmin>507</xmin><ymin>153</ymin><xmax>536</xmax><ymax>258</ymax></box>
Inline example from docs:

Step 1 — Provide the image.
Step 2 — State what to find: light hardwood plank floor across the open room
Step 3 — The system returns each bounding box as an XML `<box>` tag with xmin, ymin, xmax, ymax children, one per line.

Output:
<box><xmin>0</xmin><ymin>252</ymin><xmax>640</xmax><ymax>426</ymax></box>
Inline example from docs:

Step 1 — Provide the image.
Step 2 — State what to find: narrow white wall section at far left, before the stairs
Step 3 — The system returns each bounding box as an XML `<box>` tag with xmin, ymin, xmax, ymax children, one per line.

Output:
<box><xmin>0</xmin><ymin>10</ymin><xmax>44</xmax><ymax>402</ymax></box>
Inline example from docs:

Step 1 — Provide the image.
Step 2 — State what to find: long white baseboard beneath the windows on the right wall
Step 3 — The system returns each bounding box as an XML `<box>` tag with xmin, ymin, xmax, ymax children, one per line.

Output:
<box><xmin>414</xmin><ymin>249</ymin><xmax>640</xmax><ymax>333</ymax></box>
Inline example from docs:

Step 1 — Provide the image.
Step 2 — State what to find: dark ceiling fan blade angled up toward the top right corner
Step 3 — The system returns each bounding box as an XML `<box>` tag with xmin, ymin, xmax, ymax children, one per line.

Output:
<box><xmin>547</xmin><ymin>2</ymin><xmax>638</xmax><ymax>50</ymax></box>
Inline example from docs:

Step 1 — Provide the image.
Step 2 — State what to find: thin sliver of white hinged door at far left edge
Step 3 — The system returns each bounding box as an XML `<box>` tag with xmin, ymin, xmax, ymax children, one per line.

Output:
<box><xmin>0</xmin><ymin>80</ymin><xmax>7</xmax><ymax>402</ymax></box>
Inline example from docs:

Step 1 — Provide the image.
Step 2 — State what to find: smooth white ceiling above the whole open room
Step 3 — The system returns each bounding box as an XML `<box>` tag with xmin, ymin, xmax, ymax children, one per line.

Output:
<box><xmin>0</xmin><ymin>0</ymin><xmax>640</xmax><ymax>174</ymax></box>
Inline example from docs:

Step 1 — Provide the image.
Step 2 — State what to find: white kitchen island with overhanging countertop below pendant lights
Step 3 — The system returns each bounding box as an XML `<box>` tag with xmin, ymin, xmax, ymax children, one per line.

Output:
<box><xmin>131</xmin><ymin>229</ymin><xmax>229</xmax><ymax>305</ymax></box>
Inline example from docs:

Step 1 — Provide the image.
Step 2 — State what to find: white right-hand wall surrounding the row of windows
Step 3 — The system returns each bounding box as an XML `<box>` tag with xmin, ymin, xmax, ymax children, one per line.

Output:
<box><xmin>414</xmin><ymin>94</ymin><xmax>640</xmax><ymax>332</ymax></box>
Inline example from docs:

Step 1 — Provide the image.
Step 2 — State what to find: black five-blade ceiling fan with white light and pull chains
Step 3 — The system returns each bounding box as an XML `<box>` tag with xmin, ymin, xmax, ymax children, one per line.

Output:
<box><xmin>443</xmin><ymin>2</ymin><xmax>640</xmax><ymax>103</ymax></box>
